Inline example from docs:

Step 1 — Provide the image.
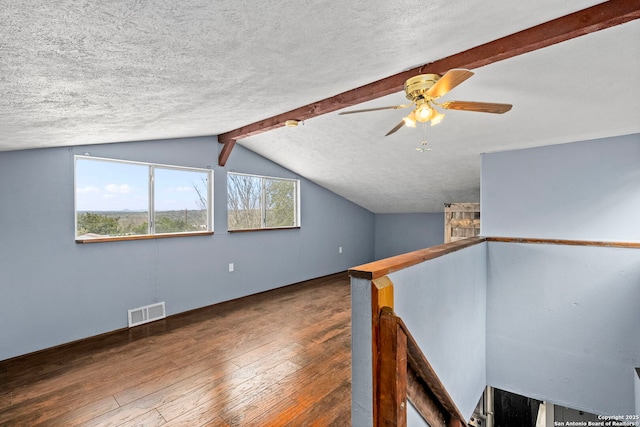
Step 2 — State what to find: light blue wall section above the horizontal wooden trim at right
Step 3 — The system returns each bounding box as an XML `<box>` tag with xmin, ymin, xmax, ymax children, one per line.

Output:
<box><xmin>481</xmin><ymin>134</ymin><xmax>640</xmax><ymax>242</ymax></box>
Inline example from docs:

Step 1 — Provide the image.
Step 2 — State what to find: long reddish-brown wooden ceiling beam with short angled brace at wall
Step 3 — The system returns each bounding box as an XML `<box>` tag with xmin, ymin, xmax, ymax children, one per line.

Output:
<box><xmin>218</xmin><ymin>0</ymin><xmax>640</xmax><ymax>166</ymax></box>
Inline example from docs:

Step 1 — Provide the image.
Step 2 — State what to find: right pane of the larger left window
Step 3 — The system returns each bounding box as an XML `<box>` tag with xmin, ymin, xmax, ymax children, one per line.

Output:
<box><xmin>153</xmin><ymin>167</ymin><xmax>209</xmax><ymax>233</ymax></box>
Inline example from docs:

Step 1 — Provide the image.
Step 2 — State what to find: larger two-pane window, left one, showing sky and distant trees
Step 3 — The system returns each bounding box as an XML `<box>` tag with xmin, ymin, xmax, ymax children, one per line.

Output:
<box><xmin>75</xmin><ymin>156</ymin><xmax>213</xmax><ymax>242</ymax></box>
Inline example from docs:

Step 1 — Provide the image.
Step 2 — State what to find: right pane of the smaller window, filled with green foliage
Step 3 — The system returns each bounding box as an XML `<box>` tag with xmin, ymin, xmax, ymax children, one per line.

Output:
<box><xmin>265</xmin><ymin>178</ymin><xmax>296</xmax><ymax>228</ymax></box>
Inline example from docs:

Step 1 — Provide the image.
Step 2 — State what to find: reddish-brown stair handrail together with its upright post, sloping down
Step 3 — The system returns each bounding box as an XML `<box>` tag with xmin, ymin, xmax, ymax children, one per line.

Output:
<box><xmin>374</xmin><ymin>307</ymin><xmax>466</xmax><ymax>427</ymax></box>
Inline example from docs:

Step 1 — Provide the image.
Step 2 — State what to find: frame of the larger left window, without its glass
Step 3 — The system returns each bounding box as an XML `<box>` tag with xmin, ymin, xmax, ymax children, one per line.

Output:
<box><xmin>73</xmin><ymin>154</ymin><xmax>214</xmax><ymax>243</ymax></box>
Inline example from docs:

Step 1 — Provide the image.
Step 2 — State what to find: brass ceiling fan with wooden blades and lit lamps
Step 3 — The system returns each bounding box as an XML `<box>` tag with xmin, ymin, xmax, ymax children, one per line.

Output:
<box><xmin>339</xmin><ymin>69</ymin><xmax>512</xmax><ymax>136</ymax></box>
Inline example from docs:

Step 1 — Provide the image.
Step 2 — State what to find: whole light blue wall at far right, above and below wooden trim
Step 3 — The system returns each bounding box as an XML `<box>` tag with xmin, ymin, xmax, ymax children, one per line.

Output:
<box><xmin>481</xmin><ymin>134</ymin><xmax>640</xmax><ymax>414</ymax></box>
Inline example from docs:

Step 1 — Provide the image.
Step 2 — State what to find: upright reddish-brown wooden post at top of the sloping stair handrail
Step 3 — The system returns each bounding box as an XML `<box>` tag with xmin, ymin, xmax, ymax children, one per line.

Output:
<box><xmin>376</xmin><ymin>307</ymin><xmax>407</xmax><ymax>426</ymax></box>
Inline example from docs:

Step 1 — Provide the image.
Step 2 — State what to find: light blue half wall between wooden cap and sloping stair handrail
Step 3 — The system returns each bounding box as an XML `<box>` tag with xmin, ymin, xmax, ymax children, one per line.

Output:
<box><xmin>389</xmin><ymin>243</ymin><xmax>487</xmax><ymax>419</ymax></box>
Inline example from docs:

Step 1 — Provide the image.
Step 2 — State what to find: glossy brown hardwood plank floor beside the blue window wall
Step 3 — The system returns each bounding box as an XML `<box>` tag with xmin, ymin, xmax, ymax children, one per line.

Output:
<box><xmin>0</xmin><ymin>273</ymin><xmax>351</xmax><ymax>427</ymax></box>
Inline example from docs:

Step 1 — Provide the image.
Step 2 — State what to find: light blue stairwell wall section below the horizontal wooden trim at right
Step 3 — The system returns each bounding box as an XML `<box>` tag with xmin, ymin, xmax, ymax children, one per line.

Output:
<box><xmin>487</xmin><ymin>242</ymin><xmax>640</xmax><ymax>415</ymax></box>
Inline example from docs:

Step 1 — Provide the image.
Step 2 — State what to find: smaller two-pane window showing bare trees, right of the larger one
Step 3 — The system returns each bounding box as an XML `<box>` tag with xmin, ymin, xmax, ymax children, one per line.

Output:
<box><xmin>227</xmin><ymin>172</ymin><xmax>300</xmax><ymax>231</ymax></box>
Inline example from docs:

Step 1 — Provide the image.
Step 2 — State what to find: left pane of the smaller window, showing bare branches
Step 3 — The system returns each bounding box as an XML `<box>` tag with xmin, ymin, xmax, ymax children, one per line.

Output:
<box><xmin>227</xmin><ymin>173</ymin><xmax>262</xmax><ymax>230</ymax></box>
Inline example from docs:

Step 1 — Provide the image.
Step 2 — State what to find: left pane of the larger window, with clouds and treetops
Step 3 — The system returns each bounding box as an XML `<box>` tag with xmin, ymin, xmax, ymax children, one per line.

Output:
<box><xmin>75</xmin><ymin>158</ymin><xmax>149</xmax><ymax>239</ymax></box>
